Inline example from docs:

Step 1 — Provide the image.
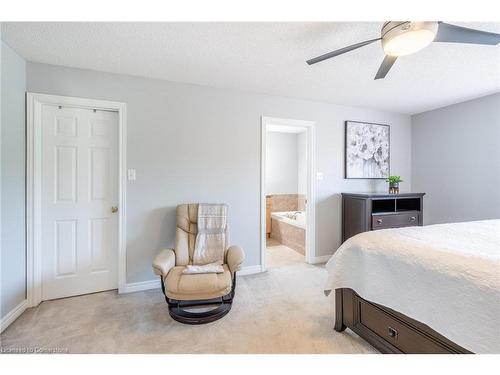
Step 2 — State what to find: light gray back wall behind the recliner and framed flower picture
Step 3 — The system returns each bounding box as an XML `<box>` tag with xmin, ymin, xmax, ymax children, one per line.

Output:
<box><xmin>27</xmin><ymin>63</ymin><xmax>411</xmax><ymax>282</ymax></box>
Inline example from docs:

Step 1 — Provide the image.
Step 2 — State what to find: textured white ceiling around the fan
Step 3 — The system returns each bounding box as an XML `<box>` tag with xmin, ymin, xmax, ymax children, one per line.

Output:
<box><xmin>2</xmin><ymin>22</ymin><xmax>500</xmax><ymax>114</ymax></box>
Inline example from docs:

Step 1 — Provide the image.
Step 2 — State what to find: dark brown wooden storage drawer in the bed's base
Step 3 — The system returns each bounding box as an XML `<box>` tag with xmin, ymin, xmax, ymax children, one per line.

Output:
<box><xmin>359</xmin><ymin>301</ymin><xmax>449</xmax><ymax>354</ymax></box>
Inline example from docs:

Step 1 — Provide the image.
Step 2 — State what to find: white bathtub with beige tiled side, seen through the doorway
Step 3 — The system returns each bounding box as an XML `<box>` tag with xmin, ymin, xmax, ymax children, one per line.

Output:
<box><xmin>271</xmin><ymin>211</ymin><xmax>306</xmax><ymax>255</ymax></box>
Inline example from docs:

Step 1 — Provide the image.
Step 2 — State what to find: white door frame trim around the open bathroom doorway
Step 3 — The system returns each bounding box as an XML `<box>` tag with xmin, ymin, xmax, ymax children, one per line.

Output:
<box><xmin>260</xmin><ymin>116</ymin><xmax>316</xmax><ymax>271</ymax></box>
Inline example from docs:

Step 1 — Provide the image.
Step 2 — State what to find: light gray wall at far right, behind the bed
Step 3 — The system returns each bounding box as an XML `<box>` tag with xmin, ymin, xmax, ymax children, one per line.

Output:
<box><xmin>412</xmin><ymin>94</ymin><xmax>500</xmax><ymax>224</ymax></box>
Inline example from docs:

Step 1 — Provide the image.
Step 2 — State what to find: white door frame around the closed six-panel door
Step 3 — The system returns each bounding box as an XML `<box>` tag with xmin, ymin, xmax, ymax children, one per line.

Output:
<box><xmin>26</xmin><ymin>92</ymin><xmax>127</xmax><ymax>307</ymax></box>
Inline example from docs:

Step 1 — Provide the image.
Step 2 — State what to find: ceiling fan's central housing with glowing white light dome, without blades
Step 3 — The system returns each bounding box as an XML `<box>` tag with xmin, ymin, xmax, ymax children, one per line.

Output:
<box><xmin>381</xmin><ymin>21</ymin><xmax>439</xmax><ymax>56</ymax></box>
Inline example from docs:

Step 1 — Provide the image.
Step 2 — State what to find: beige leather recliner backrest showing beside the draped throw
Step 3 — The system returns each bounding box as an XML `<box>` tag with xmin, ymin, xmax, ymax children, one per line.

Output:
<box><xmin>175</xmin><ymin>203</ymin><xmax>228</xmax><ymax>266</ymax></box>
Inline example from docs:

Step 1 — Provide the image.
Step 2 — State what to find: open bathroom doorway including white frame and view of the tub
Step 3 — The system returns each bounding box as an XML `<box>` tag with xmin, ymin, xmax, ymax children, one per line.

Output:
<box><xmin>261</xmin><ymin>117</ymin><xmax>315</xmax><ymax>271</ymax></box>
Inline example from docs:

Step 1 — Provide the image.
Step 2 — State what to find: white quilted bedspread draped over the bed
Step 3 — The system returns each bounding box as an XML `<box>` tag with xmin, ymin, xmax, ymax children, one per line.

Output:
<box><xmin>325</xmin><ymin>220</ymin><xmax>500</xmax><ymax>353</ymax></box>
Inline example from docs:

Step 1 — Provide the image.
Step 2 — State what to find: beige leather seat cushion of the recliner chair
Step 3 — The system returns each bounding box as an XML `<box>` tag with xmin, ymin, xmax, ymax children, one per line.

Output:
<box><xmin>164</xmin><ymin>264</ymin><xmax>232</xmax><ymax>301</ymax></box>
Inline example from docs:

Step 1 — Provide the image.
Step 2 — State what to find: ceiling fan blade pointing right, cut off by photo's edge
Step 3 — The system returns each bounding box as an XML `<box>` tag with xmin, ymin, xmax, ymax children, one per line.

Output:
<box><xmin>434</xmin><ymin>22</ymin><xmax>500</xmax><ymax>45</ymax></box>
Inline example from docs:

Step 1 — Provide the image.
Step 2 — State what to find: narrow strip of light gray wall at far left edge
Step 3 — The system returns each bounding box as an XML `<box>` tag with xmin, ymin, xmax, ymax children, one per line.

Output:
<box><xmin>0</xmin><ymin>42</ymin><xmax>26</xmax><ymax>317</ymax></box>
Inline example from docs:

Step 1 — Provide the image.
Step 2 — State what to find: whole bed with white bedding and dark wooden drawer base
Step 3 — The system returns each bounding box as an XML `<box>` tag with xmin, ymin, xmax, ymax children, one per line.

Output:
<box><xmin>325</xmin><ymin>220</ymin><xmax>500</xmax><ymax>353</ymax></box>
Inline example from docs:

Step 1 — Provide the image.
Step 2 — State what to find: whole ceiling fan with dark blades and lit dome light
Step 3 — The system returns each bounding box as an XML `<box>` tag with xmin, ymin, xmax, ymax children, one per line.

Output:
<box><xmin>306</xmin><ymin>21</ymin><xmax>500</xmax><ymax>79</ymax></box>
